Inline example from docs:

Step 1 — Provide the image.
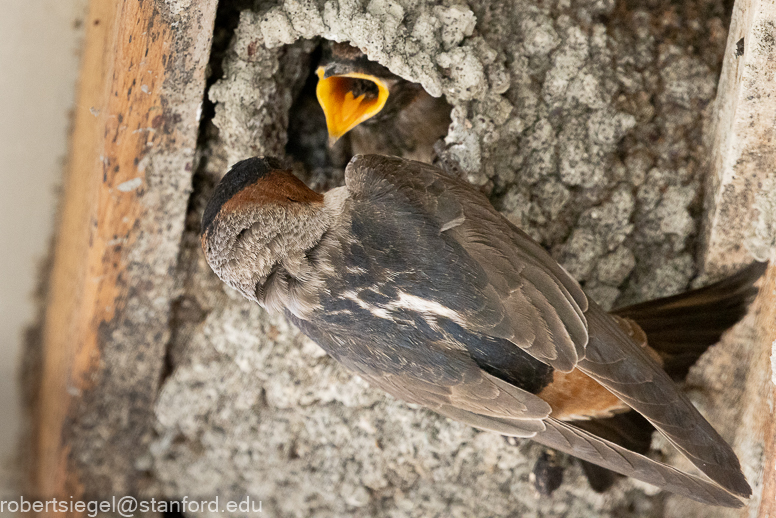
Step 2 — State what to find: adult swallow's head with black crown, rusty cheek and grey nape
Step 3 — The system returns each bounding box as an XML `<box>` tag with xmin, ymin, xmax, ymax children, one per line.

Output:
<box><xmin>200</xmin><ymin>157</ymin><xmax>327</xmax><ymax>303</ymax></box>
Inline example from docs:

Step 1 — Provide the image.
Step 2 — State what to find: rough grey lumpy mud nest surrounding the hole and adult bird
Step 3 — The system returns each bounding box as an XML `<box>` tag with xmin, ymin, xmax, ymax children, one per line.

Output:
<box><xmin>149</xmin><ymin>0</ymin><xmax>748</xmax><ymax>517</ymax></box>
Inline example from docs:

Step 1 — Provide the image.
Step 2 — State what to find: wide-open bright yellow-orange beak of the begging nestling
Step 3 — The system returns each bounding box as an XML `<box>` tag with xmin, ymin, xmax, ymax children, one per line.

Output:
<box><xmin>316</xmin><ymin>67</ymin><xmax>388</xmax><ymax>146</ymax></box>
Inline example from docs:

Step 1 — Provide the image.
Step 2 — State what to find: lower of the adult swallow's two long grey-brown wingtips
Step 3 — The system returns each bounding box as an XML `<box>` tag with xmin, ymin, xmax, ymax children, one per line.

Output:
<box><xmin>532</xmin><ymin>418</ymin><xmax>744</xmax><ymax>507</ymax></box>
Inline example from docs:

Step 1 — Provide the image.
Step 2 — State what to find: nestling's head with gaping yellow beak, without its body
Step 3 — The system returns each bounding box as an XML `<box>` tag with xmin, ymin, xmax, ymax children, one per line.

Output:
<box><xmin>316</xmin><ymin>43</ymin><xmax>406</xmax><ymax>145</ymax></box>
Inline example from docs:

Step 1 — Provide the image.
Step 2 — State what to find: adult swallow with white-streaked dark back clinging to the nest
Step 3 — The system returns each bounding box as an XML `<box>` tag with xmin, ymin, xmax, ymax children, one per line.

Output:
<box><xmin>201</xmin><ymin>155</ymin><xmax>762</xmax><ymax>507</ymax></box>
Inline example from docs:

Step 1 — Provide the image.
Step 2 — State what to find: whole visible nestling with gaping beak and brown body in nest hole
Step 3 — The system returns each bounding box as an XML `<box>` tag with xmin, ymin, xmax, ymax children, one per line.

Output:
<box><xmin>316</xmin><ymin>43</ymin><xmax>451</xmax><ymax>163</ymax></box>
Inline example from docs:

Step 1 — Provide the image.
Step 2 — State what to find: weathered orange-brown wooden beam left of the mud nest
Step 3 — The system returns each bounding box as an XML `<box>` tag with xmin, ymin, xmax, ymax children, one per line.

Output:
<box><xmin>33</xmin><ymin>0</ymin><xmax>217</xmax><ymax>516</ymax></box>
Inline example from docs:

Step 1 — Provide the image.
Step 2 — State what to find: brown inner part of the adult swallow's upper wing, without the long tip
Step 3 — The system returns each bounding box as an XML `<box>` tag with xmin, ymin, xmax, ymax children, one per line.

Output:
<box><xmin>345</xmin><ymin>155</ymin><xmax>587</xmax><ymax>372</ymax></box>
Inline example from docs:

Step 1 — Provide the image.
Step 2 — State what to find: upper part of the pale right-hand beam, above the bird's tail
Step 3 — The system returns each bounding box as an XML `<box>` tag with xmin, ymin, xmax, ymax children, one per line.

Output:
<box><xmin>704</xmin><ymin>0</ymin><xmax>776</xmax><ymax>273</ymax></box>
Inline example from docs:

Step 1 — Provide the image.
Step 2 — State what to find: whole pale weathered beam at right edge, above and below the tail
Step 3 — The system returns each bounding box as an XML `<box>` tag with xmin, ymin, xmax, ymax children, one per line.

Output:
<box><xmin>703</xmin><ymin>0</ymin><xmax>776</xmax><ymax>518</ymax></box>
